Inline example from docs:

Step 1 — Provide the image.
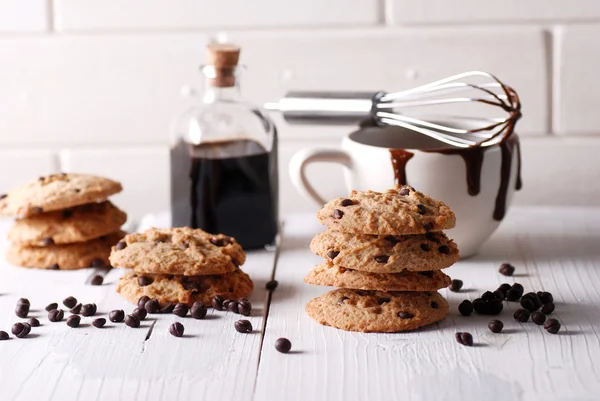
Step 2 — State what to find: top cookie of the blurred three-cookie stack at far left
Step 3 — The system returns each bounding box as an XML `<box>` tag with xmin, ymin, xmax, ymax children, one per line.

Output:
<box><xmin>0</xmin><ymin>173</ymin><xmax>123</xmax><ymax>217</ymax></box>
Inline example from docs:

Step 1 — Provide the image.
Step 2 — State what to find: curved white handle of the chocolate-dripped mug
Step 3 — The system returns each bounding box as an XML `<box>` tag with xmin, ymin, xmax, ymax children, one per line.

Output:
<box><xmin>289</xmin><ymin>148</ymin><xmax>352</xmax><ymax>206</ymax></box>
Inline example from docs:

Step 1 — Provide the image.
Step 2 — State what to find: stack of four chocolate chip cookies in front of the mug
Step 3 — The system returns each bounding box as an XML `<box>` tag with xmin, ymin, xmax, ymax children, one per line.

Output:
<box><xmin>304</xmin><ymin>186</ymin><xmax>459</xmax><ymax>332</ymax></box>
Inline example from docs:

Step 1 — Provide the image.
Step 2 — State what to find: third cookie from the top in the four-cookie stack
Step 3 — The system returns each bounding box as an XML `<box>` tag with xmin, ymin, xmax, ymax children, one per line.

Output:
<box><xmin>304</xmin><ymin>262</ymin><xmax>452</xmax><ymax>291</ymax></box>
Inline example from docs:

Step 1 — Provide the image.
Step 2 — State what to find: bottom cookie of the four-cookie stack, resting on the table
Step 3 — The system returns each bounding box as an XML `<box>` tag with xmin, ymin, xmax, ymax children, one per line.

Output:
<box><xmin>306</xmin><ymin>289</ymin><xmax>449</xmax><ymax>333</ymax></box>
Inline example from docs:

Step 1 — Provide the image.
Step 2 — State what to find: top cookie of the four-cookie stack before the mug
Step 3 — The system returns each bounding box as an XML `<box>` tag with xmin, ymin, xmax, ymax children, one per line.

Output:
<box><xmin>317</xmin><ymin>185</ymin><xmax>456</xmax><ymax>235</ymax></box>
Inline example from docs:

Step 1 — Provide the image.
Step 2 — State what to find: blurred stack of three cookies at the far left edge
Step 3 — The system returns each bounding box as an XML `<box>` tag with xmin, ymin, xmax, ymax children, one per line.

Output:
<box><xmin>0</xmin><ymin>173</ymin><xmax>127</xmax><ymax>270</ymax></box>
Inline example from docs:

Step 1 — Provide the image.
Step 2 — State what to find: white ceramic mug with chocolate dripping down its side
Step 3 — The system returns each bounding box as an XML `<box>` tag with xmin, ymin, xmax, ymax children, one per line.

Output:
<box><xmin>290</xmin><ymin>125</ymin><xmax>520</xmax><ymax>257</ymax></box>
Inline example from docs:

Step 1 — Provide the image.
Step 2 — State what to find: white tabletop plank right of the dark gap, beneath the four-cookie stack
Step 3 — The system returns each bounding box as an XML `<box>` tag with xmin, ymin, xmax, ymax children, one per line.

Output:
<box><xmin>255</xmin><ymin>208</ymin><xmax>600</xmax><ymax>401</ymax></box>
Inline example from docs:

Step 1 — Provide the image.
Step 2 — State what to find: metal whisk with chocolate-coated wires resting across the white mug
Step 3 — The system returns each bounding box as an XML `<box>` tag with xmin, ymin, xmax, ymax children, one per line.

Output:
<box><xmin>265</xmin><ymin>71</ymin><xmax>521</xmax><ymax>148</ymax></box>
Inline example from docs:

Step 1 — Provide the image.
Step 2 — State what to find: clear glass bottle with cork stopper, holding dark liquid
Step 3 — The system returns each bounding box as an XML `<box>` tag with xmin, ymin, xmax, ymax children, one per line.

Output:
<box><xmin>171</xmin><ymin>44</ymin><xmax>278</xmax><ymax>249</ymax></box>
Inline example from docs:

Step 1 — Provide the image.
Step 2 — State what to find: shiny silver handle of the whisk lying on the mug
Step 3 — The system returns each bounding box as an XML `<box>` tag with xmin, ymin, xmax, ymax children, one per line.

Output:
<box><xmin>265</xmin><ymin>91</ymin><xmax>381</xmax><ymax>125</ymax></box>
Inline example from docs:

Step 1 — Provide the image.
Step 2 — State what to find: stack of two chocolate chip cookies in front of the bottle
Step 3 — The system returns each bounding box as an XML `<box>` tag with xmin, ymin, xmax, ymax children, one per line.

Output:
<box><xmin>110</xmin><ymin>227</ymin><xmax>254</xmax><ymax>308</ymax></box>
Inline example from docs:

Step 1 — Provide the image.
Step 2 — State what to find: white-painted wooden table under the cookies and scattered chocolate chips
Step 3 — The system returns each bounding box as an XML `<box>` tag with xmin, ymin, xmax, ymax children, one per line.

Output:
<box><xmin>0</xmin><ymin>208</ymin><xmax>600</xmax><ymax>401</ymax></box>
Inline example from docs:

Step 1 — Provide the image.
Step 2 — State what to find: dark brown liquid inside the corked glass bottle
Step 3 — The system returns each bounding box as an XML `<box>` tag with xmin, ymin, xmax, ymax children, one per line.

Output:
<box><xmin>171</xmin><ymin>140</ymin><xmax>278</xmax><ymax>249</ymax></box>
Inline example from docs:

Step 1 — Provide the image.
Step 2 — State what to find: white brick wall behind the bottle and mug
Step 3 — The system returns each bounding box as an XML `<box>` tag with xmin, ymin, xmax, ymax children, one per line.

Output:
<box><xmin>0</xmin><ymin>0</ymin><xmax>600</xmax><ymax>216</ymax></box>
